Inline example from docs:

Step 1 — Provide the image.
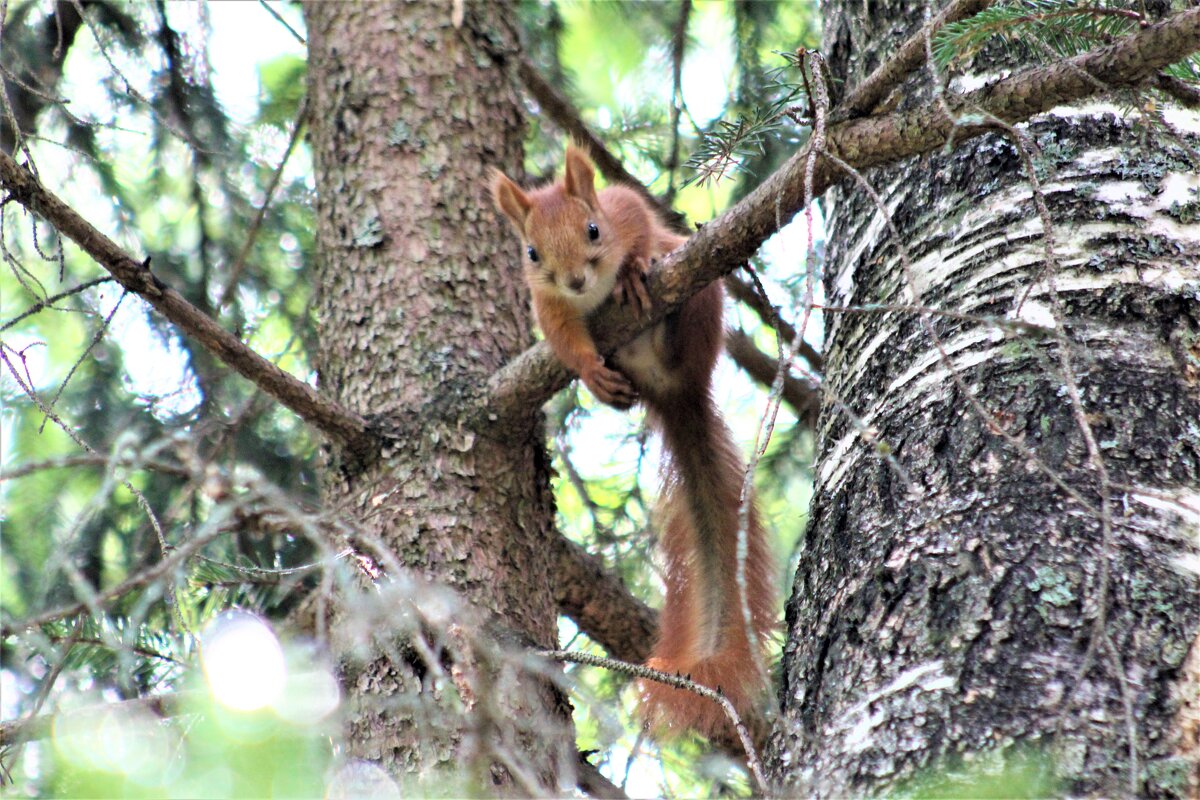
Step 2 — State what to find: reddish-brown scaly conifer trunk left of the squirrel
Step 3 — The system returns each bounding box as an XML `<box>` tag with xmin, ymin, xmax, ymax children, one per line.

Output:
<box><xmin>306</xmin><ymin>2</ymin><xmax>575</xmax><ymax>794</ymax></box>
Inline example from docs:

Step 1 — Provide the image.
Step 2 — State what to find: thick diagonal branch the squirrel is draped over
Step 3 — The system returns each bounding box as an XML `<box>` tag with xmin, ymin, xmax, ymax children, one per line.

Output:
<box><xmin>486</xmin><ymin>7</ymin><xmax>1200</xmax><ymax>419</ymax></box>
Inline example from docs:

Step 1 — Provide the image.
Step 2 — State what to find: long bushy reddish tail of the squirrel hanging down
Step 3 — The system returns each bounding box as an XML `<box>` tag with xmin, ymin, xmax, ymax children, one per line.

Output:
<box><xmin>641</xmin><ymin>386</ymin><xmax>775</xmax><ymax>734</ymax></box>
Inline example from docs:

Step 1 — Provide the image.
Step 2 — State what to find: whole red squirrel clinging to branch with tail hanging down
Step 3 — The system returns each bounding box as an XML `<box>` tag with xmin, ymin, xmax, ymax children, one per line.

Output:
<box><xmin>492</xmin><ymin>146</ymin><xmax>775</xmax><ymax>734</ymax></box>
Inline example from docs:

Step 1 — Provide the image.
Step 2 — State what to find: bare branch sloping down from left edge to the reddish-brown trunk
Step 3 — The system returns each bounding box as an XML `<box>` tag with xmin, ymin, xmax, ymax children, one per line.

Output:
<box><xmin>0</xmin><ymin>152</ymin><xmax>376</xmax><ymax>456</ymax></box>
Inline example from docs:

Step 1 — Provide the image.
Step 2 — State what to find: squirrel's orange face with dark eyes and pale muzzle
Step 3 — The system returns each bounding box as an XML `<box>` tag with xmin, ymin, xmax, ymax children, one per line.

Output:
<box><xmin>522</xmin><ymin>193</ymin><xmax>622</xmax><ymax>313</ymax></box>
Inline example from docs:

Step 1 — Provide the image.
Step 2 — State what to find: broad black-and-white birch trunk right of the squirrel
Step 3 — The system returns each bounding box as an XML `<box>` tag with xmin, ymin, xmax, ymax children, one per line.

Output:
<box><xmin>772</xmin><ymin>0</ymin><xmax>1200</xmax><ymax>798</ymax></box>
